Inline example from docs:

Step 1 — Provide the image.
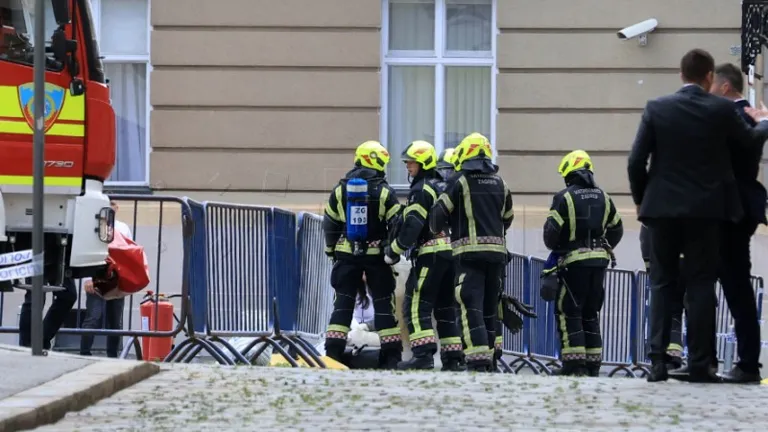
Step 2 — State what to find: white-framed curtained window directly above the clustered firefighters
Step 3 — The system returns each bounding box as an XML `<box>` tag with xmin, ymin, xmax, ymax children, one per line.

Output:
<box><xmin>381</xmin><ymin>0</ymin><xmax>496</xmax><ymax>185</ymax></box>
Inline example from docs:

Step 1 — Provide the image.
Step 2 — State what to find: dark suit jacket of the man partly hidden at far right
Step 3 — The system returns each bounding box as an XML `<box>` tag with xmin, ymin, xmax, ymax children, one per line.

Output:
<box><xmin>731</xmin><ymin>99</ymin><xmax>768</xmax><ymax>224</ymax></box>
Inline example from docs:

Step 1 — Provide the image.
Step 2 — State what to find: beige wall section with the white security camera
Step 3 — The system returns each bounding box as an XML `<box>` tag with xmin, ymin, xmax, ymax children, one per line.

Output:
<box><xmin>497</xmin><ymin>0</ymin><xmax>741</xmax><ymax>198</ymax></box>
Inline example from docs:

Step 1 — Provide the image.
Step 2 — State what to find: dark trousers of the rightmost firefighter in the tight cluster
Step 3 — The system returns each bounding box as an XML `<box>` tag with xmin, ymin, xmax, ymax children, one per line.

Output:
<box><xmin>454</xmin><ymin>258</ymin><xmax>505</xmax><ymax>363</ymax></box>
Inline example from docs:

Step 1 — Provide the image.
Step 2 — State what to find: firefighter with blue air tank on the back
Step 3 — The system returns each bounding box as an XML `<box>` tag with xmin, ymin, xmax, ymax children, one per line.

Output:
<box><xmin>323</xmin><ymin>141</ymin><xmax>402</xmax><ymax>369</ymax></box>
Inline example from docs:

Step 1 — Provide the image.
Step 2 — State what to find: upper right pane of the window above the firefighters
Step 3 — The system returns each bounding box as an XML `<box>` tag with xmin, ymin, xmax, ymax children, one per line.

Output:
<box><xmin>445</xmin><ymin>0</ymin><xmax>493</xmax><ymax>52</ymax></box>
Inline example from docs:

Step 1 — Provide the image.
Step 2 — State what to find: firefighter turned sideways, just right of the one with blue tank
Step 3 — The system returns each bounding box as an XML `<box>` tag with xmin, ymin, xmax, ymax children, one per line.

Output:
<box><xmin>385</xmin><ymin>141</ymin><xmax>464</xmax><ymax>371</ymax></box>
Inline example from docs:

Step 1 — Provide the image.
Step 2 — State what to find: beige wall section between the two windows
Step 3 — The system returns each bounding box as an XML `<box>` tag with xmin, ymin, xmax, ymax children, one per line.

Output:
<box><xmin>150</xmin><ymin>0</ymin><xmax>381</xmax><ymax>194</ymax></box>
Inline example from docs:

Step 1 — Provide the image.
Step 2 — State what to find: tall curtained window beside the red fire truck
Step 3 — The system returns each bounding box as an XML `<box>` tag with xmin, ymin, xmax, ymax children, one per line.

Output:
<box><xmin>91</xmin><ymin>0</ymin><xmax>150</xmax><ymax>186</ymax></box>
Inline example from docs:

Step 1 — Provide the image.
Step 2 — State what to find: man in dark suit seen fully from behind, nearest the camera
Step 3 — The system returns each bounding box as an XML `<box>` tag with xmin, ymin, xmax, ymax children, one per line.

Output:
<box><xmin>627</xmin><ymin>49</ymin><xmax>768</xmax><ymax>382</ymax></box>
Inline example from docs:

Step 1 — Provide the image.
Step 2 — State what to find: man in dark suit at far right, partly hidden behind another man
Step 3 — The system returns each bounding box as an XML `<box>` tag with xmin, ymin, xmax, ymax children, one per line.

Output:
<box><xmin>710</xmin><ymin>63</ymin><xmax>768</xmax><ymax>383</ymax></box>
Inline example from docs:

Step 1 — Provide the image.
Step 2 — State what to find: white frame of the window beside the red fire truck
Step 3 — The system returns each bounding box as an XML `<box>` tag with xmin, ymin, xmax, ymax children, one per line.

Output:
<box><xmin>91</xmin><ymin>0</ymin><xmax>152</xmax><ymax>188</ymax></box>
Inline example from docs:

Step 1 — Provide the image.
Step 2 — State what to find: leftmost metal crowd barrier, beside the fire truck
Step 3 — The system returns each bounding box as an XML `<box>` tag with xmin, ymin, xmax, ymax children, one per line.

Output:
<box><xmin>0</xmin><ymin>195</ymin><xmax>193</xmax><ymax>360</ymax></box>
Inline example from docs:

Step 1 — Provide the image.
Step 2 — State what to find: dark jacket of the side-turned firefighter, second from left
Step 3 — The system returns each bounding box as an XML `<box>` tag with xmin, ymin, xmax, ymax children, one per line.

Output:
<box><xmin>391</xmin><ymin>170</ymin><xmax>451</xmax><ymax>259</ymax></box>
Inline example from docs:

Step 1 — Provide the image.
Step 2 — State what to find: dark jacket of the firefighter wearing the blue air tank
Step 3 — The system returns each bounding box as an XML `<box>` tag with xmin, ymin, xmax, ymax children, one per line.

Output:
<box><xmin>323</xmin><ymin>166</ymin><xmax>401</xmax><ymax>259</ymax></box>
